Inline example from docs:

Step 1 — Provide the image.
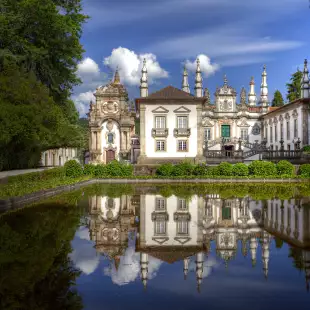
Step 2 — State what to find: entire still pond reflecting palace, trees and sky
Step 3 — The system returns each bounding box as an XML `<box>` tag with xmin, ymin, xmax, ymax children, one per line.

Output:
<box><xmin>0</xmin><ymin>185</ymin><xmax>310</xmax><ymax>310</ymax></box>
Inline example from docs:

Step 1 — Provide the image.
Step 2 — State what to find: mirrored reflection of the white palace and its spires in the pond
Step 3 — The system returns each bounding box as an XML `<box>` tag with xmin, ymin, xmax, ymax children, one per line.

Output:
<box><xmin>89</xmin><ymin>194</ymin><xmax>310</xmax><ymax>290</ymax></box>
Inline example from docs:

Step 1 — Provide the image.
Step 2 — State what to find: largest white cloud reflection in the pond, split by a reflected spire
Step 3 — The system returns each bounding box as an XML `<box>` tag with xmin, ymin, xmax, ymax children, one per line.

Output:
<box><xmin>104</xmin><ymin>246</ymin><xmax>162</xmax><ymax>285</ymax></box>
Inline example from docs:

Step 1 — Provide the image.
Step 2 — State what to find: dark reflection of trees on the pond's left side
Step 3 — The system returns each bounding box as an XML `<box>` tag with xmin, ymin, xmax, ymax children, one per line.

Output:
<box><xmin>0</xmin><ymin>204</ymin><xmax>83</xmax><ymax>310</ymax></box>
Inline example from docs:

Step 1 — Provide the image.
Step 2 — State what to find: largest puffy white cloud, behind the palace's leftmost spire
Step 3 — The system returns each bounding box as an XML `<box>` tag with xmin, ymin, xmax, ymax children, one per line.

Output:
<box><xmin>103</xmin><ymin>47</ymin><xmax>168</xmax><ymax>86</ymax></box>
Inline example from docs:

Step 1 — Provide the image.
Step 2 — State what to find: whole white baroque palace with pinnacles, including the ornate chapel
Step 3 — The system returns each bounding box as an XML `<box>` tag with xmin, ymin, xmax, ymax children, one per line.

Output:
<box><xmin>88</xmin><ymin>59</ymin><xmax>310</xmax><ymax>165</ymax></box>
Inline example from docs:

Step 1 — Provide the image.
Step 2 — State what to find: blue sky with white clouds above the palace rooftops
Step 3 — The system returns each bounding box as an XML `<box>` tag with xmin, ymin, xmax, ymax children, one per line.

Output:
<box><xmin>72</xmin><ymin>0</ymin><xmax>310</xmax><ymax>117</ymax></box>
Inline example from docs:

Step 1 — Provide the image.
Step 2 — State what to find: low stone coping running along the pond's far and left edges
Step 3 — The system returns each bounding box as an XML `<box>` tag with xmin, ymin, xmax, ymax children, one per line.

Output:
<box><xmin>0</xmin><ymin>178</ymin><xmax>309</xmax><ymax>212</ymax></box>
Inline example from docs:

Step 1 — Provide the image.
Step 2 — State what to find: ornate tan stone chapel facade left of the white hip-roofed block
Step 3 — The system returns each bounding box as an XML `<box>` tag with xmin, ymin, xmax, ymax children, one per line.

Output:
<box><xmin>88</xmin><ymin>70</ymin><xmax>135</xmax><ymax>164</ymax></box>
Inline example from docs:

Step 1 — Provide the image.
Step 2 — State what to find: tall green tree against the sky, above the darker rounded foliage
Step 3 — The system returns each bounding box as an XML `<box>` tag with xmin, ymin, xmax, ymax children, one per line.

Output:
<box><xmin>0</xmin><ymin>0</ymin><xmax>88</xmax><ymax>107</ymax></box>
